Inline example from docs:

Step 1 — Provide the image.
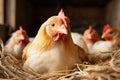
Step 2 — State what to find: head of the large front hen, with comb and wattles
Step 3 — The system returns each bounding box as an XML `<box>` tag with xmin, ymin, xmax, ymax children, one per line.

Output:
<box><xmin>41</xmin><ymin>10</ymin><xmax>69</xmax><ymax>41</ymax></box>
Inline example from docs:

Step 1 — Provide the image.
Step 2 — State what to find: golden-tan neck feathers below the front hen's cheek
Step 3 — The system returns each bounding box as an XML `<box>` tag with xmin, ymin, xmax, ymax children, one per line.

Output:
<box><xmin>31</xmin><ymin>27</ymin><xmax>55</xmax><ymax>51</ymax></box>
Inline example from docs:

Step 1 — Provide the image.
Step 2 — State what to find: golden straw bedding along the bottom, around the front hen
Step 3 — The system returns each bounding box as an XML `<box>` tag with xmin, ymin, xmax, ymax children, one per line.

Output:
<box><xmin>0</xmin><ymin>41</ymin><xmax>120</xmax><ymax>80</ymax></box>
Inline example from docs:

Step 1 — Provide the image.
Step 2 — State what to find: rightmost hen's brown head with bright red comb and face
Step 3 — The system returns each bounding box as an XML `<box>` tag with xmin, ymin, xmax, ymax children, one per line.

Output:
<box><xmin>102</xmin><ymin>24</ymin><xmax>118</xmax><ymax>41</ymax></box>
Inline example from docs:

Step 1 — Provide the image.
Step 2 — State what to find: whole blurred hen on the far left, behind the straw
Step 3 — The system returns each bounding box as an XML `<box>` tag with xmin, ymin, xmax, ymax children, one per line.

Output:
<box><xmin>5</xmin><ymin>26</ymin><xmax>29</xmax><ymax>59</ymax></box>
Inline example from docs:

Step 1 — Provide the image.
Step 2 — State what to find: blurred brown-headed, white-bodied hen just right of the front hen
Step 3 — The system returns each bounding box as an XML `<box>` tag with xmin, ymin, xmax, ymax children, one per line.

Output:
<box><xmin>84</xmin><ymin>26</ymin><xmax>111</xmax><ymax>53</ymax></box>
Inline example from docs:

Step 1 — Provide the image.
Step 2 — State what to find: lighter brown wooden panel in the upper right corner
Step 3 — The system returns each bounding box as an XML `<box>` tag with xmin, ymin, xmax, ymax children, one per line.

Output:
<box><xmin>106</xmin><ymin>0</ymin><xmax>120</xmax><ymax>30</ymax></box>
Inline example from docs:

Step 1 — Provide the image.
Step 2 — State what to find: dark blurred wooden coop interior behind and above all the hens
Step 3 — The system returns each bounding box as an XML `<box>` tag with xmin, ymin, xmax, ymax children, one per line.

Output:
<box><xmin>0</xmin><ymin>0</ymin><xmax>120</xmax><ymax>41</ymax></box>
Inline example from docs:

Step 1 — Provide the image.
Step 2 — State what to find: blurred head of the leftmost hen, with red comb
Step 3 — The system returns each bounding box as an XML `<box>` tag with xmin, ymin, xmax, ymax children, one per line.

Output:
<box><xmin>12</xmin><ymin>26</ymin><xmax>29</xmax><ymax>45</ymax></box>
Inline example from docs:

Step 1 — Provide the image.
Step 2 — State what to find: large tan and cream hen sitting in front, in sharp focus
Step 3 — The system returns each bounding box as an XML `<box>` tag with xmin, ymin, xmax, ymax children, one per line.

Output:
<box><xmin>23</xmin><ymin>10</ymin><xmax>86</xmax><ymax>73</ymax></box>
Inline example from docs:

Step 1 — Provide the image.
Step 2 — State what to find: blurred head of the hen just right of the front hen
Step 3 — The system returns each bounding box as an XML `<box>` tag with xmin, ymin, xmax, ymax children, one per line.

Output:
<box><xmin>83</xmin><ymin>26</ymin><xmax>100</xmax><ymax>43</ymax></box>
